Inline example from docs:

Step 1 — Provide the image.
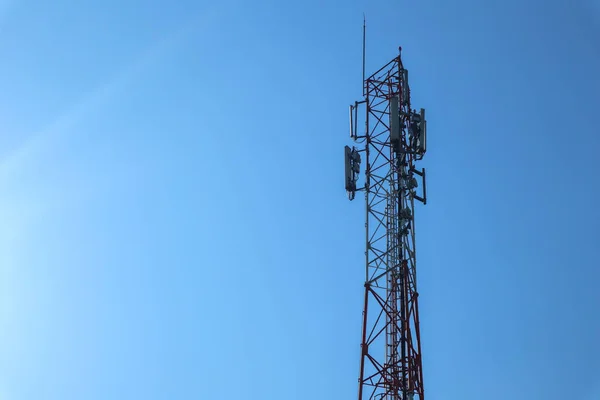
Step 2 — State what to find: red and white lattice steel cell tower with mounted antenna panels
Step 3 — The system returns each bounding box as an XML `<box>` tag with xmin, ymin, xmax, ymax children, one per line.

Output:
<box><xmin>345</xmin><ymin>45</ymin><xmax>426</xmax><ymax>400</ymax></box>
